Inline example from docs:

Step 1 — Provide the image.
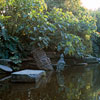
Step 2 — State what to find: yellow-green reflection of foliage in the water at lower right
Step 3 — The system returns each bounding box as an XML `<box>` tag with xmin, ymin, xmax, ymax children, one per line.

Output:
<box><xmin>57</xmin><ymin>66</ymin><xmax>93</xmax><ymax>100</ymax></box>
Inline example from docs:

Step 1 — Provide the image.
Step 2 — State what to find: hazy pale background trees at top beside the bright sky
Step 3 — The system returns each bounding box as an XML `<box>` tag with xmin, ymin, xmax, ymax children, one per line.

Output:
<box><xmin>45</xmin><ymin>0</ymin><xmax>81</xmax><ymax>13</ymax></box>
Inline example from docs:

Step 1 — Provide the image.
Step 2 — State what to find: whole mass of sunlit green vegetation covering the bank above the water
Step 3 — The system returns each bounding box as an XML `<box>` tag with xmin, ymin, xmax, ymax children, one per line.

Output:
<box><xmin>0</xmin><ymin>0</ymin><xmax>100</xmax><ymax>64</ymax></box>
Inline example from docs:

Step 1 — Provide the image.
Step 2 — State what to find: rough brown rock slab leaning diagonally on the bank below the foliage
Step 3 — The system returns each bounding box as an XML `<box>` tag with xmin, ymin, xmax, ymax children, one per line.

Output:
<box><xmin>32</xmin><ymin>48</ymin><xmax>53</xmax><ymax>70</ymax></box>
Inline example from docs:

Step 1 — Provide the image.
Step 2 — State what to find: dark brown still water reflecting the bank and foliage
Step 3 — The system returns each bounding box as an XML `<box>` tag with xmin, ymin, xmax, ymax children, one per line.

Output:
<box><xmin>0</xmin><ymin>64</ymin><xmax>100</xmax><ymax>100</ymax></box>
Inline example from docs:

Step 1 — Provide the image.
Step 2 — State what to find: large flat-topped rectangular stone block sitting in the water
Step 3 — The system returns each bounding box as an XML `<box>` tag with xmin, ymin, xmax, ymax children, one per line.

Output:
<box><xmin>11</xmin><ymin>70</ymin><xmax>46</xmax><ymax>83</ymax></box>
